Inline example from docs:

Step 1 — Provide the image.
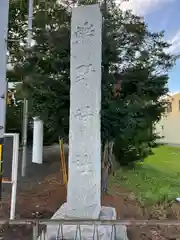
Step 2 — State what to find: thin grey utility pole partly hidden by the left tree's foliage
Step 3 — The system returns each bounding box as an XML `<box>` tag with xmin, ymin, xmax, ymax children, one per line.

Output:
<box><xmin>21</xmin><ymin>0</ymin><xmax>34</xmax><ymax>177</ymax></box>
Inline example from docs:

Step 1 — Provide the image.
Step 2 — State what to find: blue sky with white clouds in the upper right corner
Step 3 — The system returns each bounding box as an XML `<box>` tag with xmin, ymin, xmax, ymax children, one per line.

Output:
<box><xmin>118</xmin><ymin>0</ymin><xmax>180</xmax><ymax>92</ymax></box>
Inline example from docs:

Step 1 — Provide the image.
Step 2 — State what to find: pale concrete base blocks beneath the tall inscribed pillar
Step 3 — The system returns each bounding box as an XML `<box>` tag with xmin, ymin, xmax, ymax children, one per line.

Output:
<box><xmin>46</xmin><ymin>204</ymin><xmax>128</xmax><ymax>240</ymax></box>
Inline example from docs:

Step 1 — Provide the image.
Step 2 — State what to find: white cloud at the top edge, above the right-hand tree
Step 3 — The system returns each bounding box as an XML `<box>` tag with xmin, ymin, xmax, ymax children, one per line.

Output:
<box><xmin>117</xmin><ymin>0</ymin><xmax>174</xmax><ymax>16</ymax></box>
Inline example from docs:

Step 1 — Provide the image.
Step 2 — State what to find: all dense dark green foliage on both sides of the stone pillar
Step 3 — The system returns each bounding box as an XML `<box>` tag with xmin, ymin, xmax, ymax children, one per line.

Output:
<box><xmin>8</xmin><ymin>0</ymin><xmax>173</xmax><ymax>164</ymax></box>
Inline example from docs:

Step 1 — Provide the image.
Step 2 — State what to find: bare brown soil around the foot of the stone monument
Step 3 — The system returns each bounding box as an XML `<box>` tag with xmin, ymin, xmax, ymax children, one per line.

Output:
<box><xmin>0</xmin><ymin>171</ymin><xmax>180</xmax><ymax>240</ymax></box>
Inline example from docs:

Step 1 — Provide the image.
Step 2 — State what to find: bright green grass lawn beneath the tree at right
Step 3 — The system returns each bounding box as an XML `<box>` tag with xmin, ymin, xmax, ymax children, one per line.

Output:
<box><xmin>110</xmin><ymin>146</ymin><xmax>180</xmax><ymax>204</ymax></box>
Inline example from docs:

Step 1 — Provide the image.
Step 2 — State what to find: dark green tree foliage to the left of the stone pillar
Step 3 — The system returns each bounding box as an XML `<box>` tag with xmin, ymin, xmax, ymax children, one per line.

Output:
<box><xmin>8</xmin><ymin>0</ymin><xmax>70</xmax><ymax>141</ymax></box>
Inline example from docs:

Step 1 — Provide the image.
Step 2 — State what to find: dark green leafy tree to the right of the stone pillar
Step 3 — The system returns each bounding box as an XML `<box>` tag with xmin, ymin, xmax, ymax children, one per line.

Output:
<box><xmin>102</xmin><ymin>3</ymin><xmax>173</xmax><ymax>164</ymax></box>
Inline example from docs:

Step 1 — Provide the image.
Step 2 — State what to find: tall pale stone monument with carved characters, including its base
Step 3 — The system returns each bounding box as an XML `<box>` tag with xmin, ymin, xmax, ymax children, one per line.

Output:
<box><xmin>47</xmin><ymin>5</ymin><xmax>127</xmax><ymax>240</ymax></box>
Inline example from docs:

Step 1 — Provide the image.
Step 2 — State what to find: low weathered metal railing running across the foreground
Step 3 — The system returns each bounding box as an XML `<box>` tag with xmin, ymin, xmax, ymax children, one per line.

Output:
<box><xmin>0</xmin><ymin>219</ymin><xmax>180</xmax><ymax>240</ymax></box>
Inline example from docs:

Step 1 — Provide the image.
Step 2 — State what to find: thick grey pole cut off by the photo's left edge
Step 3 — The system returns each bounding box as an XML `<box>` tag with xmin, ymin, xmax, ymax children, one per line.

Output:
<box><xmin>0</xmin><ymin>0</ymin><xmax>9</xmax><ymax>200</ymax></box>
